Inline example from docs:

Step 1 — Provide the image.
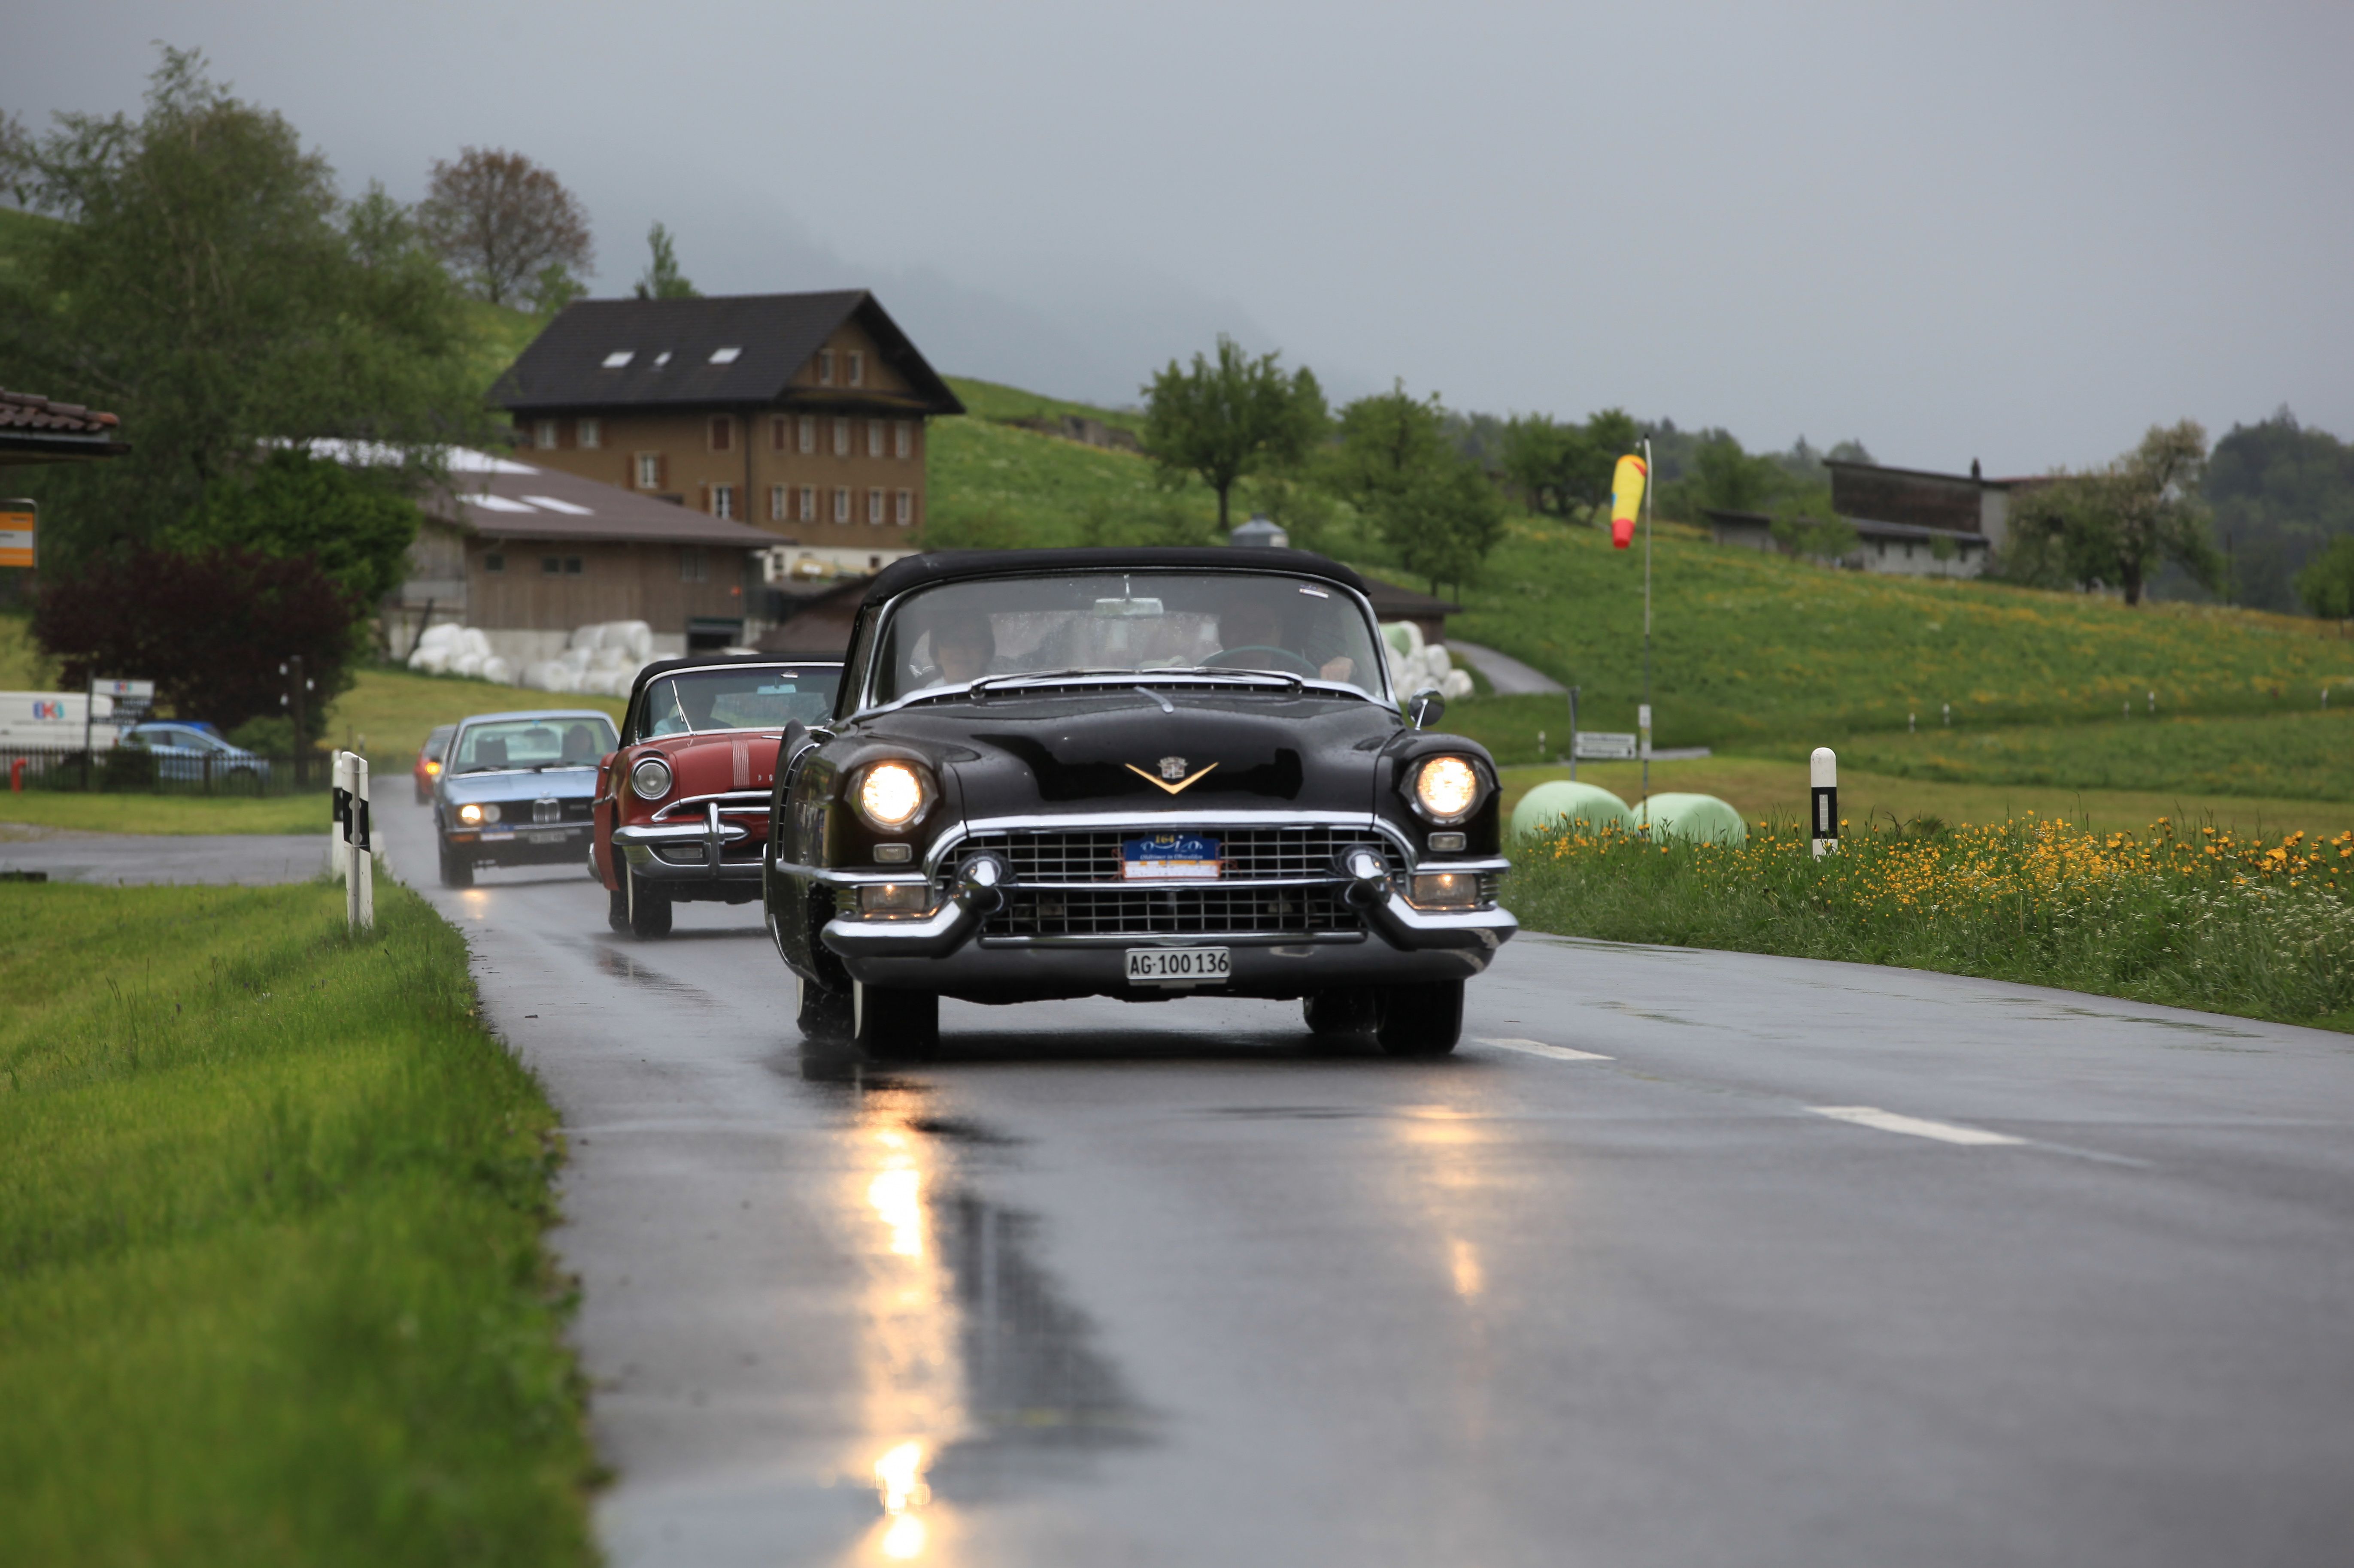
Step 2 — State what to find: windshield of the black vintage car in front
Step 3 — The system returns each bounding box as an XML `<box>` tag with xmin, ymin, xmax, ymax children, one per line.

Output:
<box><xmin>874</xmin><ymin>572</ymin><xmax>1384</xmax><ymax>702</ymax></box>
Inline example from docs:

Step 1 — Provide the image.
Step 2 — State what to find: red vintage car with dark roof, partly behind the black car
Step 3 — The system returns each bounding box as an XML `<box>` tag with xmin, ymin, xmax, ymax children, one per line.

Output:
<box><xmin>588</xmin><ymin>654</ymin><xmax>843</xmax><ymax>939</ymax></box>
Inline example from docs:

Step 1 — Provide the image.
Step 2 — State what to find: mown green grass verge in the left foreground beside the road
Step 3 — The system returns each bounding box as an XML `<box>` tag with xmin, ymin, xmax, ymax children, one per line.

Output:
<box><xmin>0</xmin><ymin>883</ymin><xmax>593</xmax><ymax>1563</ymax></box>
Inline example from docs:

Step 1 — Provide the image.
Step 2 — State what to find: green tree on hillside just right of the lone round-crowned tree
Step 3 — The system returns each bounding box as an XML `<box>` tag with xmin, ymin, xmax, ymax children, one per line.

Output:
<box><xmin>1328</xmin><ymin>386</ymin><xmax>1504</xmax><ymax>593</ymax></box>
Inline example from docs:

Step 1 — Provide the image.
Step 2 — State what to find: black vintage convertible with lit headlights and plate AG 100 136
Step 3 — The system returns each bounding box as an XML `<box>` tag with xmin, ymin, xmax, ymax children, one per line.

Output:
<box><xmin>763</xmin><ymin>548</ymin><xmax>1516</xmax><ymax>1057</ymax></box>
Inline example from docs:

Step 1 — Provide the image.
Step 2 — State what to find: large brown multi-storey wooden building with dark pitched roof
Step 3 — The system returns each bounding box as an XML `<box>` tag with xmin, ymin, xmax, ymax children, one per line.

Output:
<box><xmin>492</xmin><ymin>290</ymin><xmax>965</xmax><ymax>553</ymax></box>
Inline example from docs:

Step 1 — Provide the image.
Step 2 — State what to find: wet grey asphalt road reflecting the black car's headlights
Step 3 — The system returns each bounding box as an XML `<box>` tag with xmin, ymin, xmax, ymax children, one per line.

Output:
<box><xmin>367</xmin><ymin>808</ymin><xmax>2354</xmax><ymax>1568</ymax></box>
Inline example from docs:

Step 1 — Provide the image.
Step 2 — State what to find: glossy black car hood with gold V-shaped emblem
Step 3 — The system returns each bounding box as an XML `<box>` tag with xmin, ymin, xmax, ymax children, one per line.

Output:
<box><xmin>862</xmin><ymin>690</ymin><xmax>1403</xmax><ymax>817</ymax></box>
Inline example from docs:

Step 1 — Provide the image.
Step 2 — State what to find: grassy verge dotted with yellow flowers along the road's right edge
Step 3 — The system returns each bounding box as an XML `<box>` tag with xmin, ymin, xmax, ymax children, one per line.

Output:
<box><xmin>1507</xmin><ymin>819</ymin><xmax>2354</xmax><ymax>1029</ymax></box>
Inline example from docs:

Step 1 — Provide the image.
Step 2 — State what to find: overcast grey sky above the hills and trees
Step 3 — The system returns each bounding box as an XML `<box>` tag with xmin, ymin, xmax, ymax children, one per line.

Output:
<box><xmin>0</xmin><ymin>0</ymin><xmax>2354</xmax><ymax>473</ymax></box>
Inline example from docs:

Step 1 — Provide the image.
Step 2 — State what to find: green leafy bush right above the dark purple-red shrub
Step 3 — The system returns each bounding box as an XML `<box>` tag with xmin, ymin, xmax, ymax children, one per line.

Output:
<box><xmin>160</xmin><ymin>450</ymin><xmax>417</xmax><ymax>605</ymax></box>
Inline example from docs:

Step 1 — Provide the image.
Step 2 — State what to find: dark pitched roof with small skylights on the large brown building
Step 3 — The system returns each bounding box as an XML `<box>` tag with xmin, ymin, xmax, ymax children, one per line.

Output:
<box><xmin>490</xmin><ymin>290</ymin><xmax>965</xmax><ymax>415</ymax></box>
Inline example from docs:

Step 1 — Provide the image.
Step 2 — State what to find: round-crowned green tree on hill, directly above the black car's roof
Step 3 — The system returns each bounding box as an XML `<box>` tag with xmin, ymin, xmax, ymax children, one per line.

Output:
<box><xmin>1144</xmin><ymin>334</ymin><xmax>1330</xmax><ymax>530</ymax></box>
